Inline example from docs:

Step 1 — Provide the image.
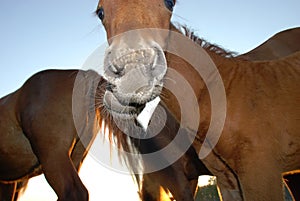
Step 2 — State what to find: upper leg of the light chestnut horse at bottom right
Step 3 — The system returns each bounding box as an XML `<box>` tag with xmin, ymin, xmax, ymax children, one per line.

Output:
<box><xmin>238</xmin><ymin>155</ymin><xmax>284</xmax><ymax>201</ymax></box>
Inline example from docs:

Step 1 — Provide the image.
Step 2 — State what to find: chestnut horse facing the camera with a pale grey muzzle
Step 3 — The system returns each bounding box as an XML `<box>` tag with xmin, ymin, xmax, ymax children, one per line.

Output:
<box><xmin>97</xmin><ymin>0</ymin><xmax>300</xmax><ymax>201</ymax></box>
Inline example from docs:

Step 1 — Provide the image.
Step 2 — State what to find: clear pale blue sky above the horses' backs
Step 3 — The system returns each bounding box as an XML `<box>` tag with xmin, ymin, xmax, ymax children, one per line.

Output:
<box><xmin>0</xmin><ymin>0</ymin><xmax>300</xmax><ymax>199</ymax></box>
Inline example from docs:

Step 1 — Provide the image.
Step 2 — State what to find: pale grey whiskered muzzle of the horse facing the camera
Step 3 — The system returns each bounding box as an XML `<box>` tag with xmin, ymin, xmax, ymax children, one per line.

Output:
<box><xmin>104</xmin><ymin>42</ymin><xmax>167</xmax><ymax>117</ymax></box>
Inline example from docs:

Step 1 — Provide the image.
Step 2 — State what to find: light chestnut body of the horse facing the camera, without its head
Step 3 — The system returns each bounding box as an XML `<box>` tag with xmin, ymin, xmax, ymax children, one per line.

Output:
<box><xmin>164</xmin><ymin>44</ymin><xmax>300</xmax><ymax>200</ymax></box>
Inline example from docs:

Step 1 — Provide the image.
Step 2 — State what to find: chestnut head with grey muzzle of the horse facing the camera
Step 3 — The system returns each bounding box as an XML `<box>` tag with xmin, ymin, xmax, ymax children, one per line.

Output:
<box><xmin>96</xmin><ymin>0</ymin><xmax>175</xmax><ymax>118</ymax></box>
